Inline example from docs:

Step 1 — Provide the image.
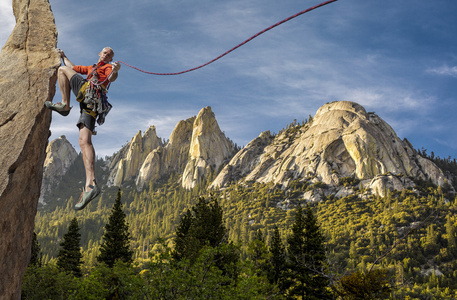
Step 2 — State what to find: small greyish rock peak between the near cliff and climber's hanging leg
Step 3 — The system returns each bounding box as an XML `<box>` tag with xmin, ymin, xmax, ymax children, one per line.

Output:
<box><xmin>40</xmin><ymin>135</ymin><xmax>78</xmax><ymax>202</ymax></box>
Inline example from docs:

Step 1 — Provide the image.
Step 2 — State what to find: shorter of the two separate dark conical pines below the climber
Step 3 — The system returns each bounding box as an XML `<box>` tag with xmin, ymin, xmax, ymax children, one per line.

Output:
<box><xmin>57</xmin><ymin>218</ymin><xmax>82</xmax><ymax>277</ymax></box>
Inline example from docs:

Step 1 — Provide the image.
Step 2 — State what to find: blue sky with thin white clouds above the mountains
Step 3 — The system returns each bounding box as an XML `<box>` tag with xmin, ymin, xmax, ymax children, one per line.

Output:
<box><xmin>0</xmin><ymin>0</ymin><xmax>457</xmax><ymax>158</ymax></box>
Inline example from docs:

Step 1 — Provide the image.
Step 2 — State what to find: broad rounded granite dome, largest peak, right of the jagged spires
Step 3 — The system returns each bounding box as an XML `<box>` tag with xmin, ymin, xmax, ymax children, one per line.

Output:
<box><xmin>211</xmin><ymin>101</ymin><xmax>446</xmax><ymax>198</ymax></box>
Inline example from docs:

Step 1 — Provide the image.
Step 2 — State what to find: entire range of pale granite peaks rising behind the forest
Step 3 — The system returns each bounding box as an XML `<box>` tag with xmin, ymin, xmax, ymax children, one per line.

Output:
<box><xmin>43</xmin><ymin>101</ymin><xmax>452</xmax><ymax>201</ymax></box>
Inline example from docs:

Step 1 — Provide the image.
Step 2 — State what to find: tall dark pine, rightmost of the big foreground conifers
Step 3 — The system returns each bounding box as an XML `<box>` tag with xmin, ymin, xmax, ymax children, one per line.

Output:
<box><xmin>287</xmin><ymin>205</ymin><xmax>328</xmax><ymax>299</ymax></box>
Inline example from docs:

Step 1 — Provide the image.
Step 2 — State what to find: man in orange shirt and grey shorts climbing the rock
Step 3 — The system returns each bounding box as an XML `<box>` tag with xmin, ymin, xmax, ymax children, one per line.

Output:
<box><xmin>45</xmin><ymin>47</ymin><xmax>120</xmax><ymax>210</ymax></box>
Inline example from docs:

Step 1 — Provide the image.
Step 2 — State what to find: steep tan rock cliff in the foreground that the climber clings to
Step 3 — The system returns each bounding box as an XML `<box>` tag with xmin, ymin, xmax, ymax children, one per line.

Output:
<box><xmin>0</xmin><ymin>0</ymin><xmax>60</xmax><ymax>299</ymax></box>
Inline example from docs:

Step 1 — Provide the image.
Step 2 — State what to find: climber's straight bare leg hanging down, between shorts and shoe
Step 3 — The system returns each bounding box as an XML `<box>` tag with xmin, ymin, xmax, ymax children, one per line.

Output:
<box><xmin>79</xmin><ymin>124</ymin><xmax>95</xmax><ymax>192</ymax></box>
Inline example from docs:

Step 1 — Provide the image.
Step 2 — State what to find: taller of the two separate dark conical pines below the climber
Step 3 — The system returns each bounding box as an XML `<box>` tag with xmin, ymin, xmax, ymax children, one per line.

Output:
<box><xmin>97</xmin><ymin>189</ymin><xmax>133</xmax><ymax>268</ymax></box>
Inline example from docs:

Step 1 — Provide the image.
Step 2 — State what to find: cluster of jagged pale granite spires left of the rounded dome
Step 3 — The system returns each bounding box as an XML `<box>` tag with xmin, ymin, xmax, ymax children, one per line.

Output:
<box><xmin>108</xmin><ymin>106</ymin><xmax>235</xmax><ymax>190</ymax></box>
